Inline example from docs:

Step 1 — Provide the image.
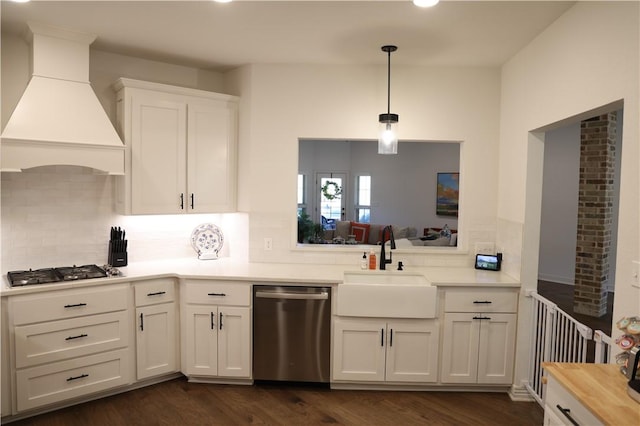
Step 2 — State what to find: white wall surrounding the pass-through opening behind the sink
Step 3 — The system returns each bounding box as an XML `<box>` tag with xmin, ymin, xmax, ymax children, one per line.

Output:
<box><xmin>230</xmin><ymin>65</ymin><xmax>499</xmax><ymax>265</ymax></box>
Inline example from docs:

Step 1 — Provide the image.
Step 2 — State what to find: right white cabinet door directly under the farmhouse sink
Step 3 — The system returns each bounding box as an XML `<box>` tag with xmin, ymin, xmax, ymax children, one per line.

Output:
<box><xmin>386</xmin><ymin>320</ymin><xmax>439</xmax><ymax>383</ymax></box>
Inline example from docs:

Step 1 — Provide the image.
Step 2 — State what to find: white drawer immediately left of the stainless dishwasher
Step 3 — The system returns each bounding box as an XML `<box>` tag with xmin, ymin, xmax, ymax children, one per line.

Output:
<box><xmin>185</xmin><ymin>280</ymin><xmax>251</xmax><ymax>306</ymax></box>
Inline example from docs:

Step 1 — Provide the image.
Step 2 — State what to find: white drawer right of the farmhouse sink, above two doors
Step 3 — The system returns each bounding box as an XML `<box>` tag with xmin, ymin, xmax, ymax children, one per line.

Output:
<box><xmin>444</xmin><ymin>288</ymin><xmax>518</xmax><ymax>312</ymax></box>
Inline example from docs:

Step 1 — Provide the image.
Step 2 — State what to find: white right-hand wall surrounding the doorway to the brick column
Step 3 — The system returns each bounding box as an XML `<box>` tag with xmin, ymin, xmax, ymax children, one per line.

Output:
<box><xmin>498</xmin><ymin>2</ymin><xmax>640</xmax><ymax>396</ymax></box>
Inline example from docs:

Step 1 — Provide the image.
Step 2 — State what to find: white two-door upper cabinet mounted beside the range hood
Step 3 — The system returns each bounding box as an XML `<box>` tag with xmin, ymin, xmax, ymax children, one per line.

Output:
<box><xmin>114</xmin><ymin>78</ymin><xmax>238</xmax><ymax>214</ymax></box>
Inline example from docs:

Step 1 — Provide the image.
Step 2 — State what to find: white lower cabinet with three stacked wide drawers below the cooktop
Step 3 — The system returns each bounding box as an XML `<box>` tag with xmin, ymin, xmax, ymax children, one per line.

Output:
<box><xmin>8</xmin><ymin>283</ymin><xmax>132</xmax><ymax>414</ymax></box>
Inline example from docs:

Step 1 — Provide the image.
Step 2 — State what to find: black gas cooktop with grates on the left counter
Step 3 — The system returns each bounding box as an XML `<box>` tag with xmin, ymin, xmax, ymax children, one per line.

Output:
<box><xmin>7</xmin><ymin>265</ymin><xmax>107</xmax><ymax>287</ymax></box>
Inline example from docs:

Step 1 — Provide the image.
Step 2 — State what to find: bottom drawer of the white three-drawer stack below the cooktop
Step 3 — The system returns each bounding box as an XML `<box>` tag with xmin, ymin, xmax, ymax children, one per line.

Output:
<box><xmin>16</xmin><ymin>349</ymin><xmax>131</xmax><ymax>411</ymax></box>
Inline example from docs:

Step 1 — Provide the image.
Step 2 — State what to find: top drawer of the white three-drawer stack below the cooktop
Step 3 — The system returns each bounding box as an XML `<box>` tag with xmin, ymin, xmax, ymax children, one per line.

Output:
<box><xmin>10</xmin><ymin>284</ymin><xmax>129</xmax><ymax>325</ymax></box>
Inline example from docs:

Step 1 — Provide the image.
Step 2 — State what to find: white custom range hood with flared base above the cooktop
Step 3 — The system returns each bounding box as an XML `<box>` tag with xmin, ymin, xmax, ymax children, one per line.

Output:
<box><xmin>0</xmin><ymin>23</ymin><xmax>124</xmax><ymax>175</ymax></box>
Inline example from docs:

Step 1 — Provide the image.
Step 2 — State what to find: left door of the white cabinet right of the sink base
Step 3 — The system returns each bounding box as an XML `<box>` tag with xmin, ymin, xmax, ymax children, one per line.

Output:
<box><xmin>441</xmin><ymin>313</ymin><xmax>480</xmax><ymax>383</ymax></box>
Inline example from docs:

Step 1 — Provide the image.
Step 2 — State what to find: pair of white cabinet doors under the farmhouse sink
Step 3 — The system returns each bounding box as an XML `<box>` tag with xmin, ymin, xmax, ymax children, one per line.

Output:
<box><xmin>333</xmin><ymin>318</ymin><xmax>438</xmax><ymax>383</ymax></box>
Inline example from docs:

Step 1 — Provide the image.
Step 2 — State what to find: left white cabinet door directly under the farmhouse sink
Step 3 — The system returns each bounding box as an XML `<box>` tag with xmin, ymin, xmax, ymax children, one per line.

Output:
<box><xmin>333</xmin><ymin>318</ymin><xmax>386</xmax><ymax>381</ymax></box>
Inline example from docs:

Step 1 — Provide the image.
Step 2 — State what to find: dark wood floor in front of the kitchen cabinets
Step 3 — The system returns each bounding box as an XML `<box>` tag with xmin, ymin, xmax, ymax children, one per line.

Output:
<box><xmin>7</xmin><ymin>378</ymin><xmax>543</xmax><ymax>426</ymax></box>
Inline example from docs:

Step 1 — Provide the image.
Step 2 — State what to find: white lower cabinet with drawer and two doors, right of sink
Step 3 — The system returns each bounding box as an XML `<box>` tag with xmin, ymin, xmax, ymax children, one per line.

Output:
<box><xmin>440</xmin><ymin>289</ymin><xmax>518</xmax><ymax>385</ymax></box>
